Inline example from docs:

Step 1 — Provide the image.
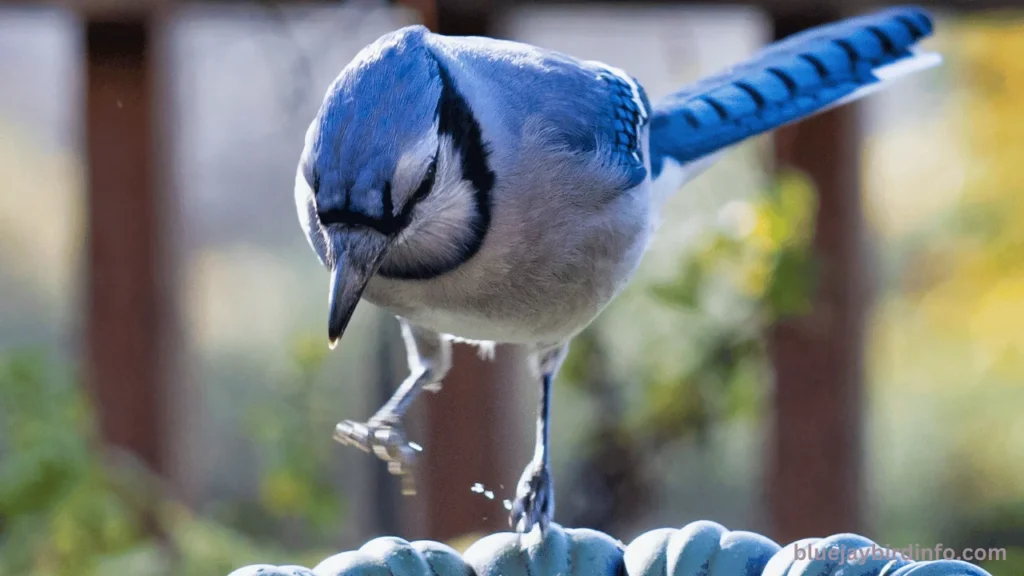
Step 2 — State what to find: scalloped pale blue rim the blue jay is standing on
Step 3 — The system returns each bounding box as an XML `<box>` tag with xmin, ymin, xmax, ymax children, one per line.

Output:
<box><xmin>228</xmin><ymin>521</ymin><xmax>991</xmax><ymax>576</ymax></box>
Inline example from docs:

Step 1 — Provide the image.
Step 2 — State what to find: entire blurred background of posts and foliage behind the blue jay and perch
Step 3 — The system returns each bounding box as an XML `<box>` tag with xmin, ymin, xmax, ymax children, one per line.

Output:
<box><xmin>0</xmin><ymin>0</ymin><xmax>1024</xmax><ymax>576</ymax></box>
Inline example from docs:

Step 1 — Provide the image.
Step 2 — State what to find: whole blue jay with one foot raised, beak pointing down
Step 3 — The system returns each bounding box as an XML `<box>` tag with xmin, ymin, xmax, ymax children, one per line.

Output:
<box><xmin>295</xmin><ymin>8</ymin><xmax>940</xmax><ymax>532</ymax></box>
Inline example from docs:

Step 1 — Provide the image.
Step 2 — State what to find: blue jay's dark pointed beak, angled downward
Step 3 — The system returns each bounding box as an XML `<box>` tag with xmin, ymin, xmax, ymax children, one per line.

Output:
<box><xmin>328</xmin><ymin>229</ymin><xmax>388</xmax><ymax>348</ymax></box>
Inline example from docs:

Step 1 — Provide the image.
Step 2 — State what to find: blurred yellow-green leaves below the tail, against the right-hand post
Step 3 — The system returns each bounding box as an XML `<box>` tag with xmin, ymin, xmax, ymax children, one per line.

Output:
<box><xmin>632</xmin><ymin>172</ymin><xmax>815</xmax><ymax>440</ymax></box>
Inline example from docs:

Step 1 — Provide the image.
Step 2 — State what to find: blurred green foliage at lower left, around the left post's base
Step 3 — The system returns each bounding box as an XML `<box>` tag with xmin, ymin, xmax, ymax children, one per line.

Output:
<box><xmin>0</xmin><ymin>344</ymin><xmax>340</xmax><ymax>576</ymax></box>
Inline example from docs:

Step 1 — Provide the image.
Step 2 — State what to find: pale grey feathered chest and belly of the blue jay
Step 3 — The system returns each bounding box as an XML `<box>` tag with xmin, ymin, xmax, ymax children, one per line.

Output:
<box><xmin>364</xmin><ymin>157</ymin><xmax>652</xmax><ymax>343</ymax></box>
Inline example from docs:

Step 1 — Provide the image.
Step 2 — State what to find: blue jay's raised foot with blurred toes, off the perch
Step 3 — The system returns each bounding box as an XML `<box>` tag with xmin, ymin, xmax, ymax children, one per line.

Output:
<box><xmin>334</xmin><ymin>416</ymin><xmax>423</xmax><ymax>495</ymax></box>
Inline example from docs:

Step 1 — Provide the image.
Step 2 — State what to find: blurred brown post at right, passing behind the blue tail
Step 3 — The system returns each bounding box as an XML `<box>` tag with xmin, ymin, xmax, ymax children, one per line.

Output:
<box><xmin>768</xmin><ymin>9</ymin><xmax>866</xmax><ymax>542</ymax></box>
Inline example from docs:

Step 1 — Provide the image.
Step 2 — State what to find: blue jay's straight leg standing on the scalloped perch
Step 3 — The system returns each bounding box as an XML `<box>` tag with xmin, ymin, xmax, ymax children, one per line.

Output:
<box><xmin>509</xmin><ymin>344</ymin><xmax>568</xmax><ymax>534</ymax></box>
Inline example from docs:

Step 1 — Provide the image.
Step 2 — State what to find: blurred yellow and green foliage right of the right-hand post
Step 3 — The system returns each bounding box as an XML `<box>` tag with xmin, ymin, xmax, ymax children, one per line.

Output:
<box><xmin>870</xmin><ymin>19</ymin><xmax>1024</xmax><ymax>576</ymax></box>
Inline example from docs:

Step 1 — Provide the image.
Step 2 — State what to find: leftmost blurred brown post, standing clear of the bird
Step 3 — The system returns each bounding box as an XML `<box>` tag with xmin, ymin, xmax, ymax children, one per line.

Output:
<box><xmin>84</xmin><ymin>14</ymin><xmax>167</xmax><ymax>474</ymax></box>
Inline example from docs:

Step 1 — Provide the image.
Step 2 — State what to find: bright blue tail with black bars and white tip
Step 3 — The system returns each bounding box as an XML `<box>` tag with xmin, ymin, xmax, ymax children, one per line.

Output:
<box><xmin>650</xmin><ymin>7</ymin><xmax>941</xmax><ymax>192</ymax></box>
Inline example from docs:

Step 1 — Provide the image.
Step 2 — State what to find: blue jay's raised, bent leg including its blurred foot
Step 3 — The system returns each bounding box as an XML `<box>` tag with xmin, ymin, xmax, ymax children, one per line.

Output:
<box><xmin>334</xmin><ymin>320</ymin><xmax>452</xmax><ymax>494</ymax></box>
